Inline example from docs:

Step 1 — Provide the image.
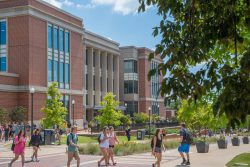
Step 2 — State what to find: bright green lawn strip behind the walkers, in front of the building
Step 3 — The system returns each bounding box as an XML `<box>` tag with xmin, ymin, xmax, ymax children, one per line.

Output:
<box><xmin>56</xmin><ymin>135</ymin><xmax>136</xmax><ymax>144</ymax></box>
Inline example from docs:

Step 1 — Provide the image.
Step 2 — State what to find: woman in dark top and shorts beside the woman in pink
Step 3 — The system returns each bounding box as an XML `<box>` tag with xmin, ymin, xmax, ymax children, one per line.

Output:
<box><xmin>30</xmin><ymin>129</ymin><xmax>42</xmax><ymax>162</ymax></box>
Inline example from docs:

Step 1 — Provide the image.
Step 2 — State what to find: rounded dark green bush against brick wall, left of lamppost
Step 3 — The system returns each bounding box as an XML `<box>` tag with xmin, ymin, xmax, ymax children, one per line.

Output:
<box><xmin>9</xmin><ymin>106</ymin><xmax>27</xmax><ymax>123</ymax></box>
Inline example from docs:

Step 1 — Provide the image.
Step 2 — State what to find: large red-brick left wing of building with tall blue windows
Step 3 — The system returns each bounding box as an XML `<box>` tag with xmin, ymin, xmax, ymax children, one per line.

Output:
<box><xmin>0</xmin><ymin>0</ymin><xmax>84</xmax><ymax>124</ymax></box>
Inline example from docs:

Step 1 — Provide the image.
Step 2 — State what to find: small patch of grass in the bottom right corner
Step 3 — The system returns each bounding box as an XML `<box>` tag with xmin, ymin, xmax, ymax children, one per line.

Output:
<box><xmin>227</xmin><ymin>153</ymin><xmax>250</xmax><ymax>167</ymax></box>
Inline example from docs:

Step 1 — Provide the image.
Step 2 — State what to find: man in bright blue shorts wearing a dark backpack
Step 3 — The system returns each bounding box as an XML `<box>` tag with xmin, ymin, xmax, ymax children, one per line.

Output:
<box><xmin>178</xmin><ymin>124</ymin><xmax>192</xmax><ymax>165</ymax></box>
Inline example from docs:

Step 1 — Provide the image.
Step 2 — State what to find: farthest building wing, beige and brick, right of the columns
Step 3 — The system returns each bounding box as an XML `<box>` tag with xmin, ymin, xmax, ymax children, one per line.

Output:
<box><xmin>119</xmin><ymin>46</ymin><xmax>166</xmax><ymax>118</ymax></box>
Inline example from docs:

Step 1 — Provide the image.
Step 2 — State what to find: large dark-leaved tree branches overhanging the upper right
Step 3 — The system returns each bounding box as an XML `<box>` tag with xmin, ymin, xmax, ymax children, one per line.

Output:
<box><xmin>139</xmin><ymin>0</ymin><xmax>250</xmax><ymax>125</ymax></box>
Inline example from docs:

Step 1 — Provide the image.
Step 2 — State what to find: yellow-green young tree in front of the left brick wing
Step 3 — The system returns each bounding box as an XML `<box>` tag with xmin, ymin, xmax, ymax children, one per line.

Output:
<box><xmin>41</xmin><ymin>82</ymin><xmax>67</xmax><ymax>128</ymax></box>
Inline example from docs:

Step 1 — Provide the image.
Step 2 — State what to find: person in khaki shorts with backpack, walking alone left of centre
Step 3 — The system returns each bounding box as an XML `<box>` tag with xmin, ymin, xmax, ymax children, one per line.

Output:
<box><xmin>67</xmin><ymin>126</ymin><xmax>80</xmax><ymax>167</ymax></box>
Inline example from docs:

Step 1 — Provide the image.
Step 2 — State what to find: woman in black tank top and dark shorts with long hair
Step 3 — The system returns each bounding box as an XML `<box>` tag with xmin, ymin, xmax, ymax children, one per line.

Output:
<box><xmin>152</xmin><ymin>129</ymin><xmax>165</xmax><ymax>167</ymax></box>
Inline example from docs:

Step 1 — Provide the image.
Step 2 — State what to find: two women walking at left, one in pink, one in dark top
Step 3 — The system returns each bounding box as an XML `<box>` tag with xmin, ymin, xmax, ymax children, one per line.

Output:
<box><xmin>8</xmin><ymin>129</ymin><xmax>42</xmax><ymax>167</ymax></box>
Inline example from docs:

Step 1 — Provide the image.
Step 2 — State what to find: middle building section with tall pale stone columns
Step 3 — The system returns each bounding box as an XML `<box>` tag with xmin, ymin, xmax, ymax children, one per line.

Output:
<box><xmin>84</xmin><ymin>31</ymin><xmax>120</xmax><ymax>121</ymax></box>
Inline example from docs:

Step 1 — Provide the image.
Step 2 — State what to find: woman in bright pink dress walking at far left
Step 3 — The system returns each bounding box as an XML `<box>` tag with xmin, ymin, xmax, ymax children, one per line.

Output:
<box><xmin>8</xmin><ymin>130</ymin><xmax>26</xmax><ymax>167</ymax></box>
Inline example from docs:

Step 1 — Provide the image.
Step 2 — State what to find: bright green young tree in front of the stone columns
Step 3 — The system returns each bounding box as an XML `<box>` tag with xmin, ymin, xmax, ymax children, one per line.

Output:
<box><xmin>95</xmin><ymin>92</ymin><xmax>123</xmax><ymax>127</ymax></box>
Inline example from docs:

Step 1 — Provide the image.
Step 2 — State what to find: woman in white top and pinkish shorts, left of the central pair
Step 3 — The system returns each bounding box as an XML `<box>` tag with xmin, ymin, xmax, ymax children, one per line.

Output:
<box><xmin>98</xmin><ymin>126</ymin><xmax>109</xmax><ymax>167</ymax></box>
